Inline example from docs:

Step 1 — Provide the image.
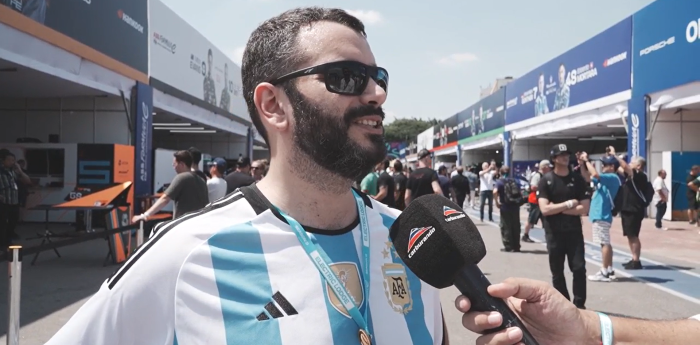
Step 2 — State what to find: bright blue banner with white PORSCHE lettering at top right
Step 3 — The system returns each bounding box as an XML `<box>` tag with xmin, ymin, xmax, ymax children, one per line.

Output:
<box><xmin>632</xmin><ymin>0</ymin><xmax>700</xmax><ymax>97</ymax></box>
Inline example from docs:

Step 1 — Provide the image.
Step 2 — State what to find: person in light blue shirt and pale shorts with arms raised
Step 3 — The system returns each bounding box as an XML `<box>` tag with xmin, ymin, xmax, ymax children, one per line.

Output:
<box><xmin>581</xmin><ymin>149</ymin><xmax>627</xmax><ymax>282</ymax></box>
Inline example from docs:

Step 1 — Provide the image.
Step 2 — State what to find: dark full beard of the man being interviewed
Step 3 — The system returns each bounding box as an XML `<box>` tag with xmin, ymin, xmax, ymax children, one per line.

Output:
<box><xmin>285</xmin><ymin>85</ymin><xmax>387</xmax><ymax>181</ymax></box>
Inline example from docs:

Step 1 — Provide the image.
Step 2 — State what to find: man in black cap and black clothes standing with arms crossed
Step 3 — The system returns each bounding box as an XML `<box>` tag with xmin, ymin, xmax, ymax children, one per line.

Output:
<box><xmin>537</xmin><ymin>144</ymin><xmax>590</xmax><ymax>309</ymax></box>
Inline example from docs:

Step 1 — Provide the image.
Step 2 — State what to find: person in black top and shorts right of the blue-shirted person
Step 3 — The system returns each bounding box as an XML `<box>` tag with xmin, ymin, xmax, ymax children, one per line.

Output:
<box><xmin>610</xmin><ymin>149</ymin><xmax>649</xmax><ymax>270</ymax></box>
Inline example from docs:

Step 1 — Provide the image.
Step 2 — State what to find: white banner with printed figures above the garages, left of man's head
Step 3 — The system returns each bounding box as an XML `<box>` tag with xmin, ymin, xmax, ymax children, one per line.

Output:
<box><xmin>150</xmin><ymin>0</ymin><xmax>249</xmax><ymax>119</ymax></box>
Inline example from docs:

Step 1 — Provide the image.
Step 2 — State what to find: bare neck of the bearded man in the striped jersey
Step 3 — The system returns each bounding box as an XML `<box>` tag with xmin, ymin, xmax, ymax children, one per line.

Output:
<box><xmin>257</xmin><ymin>160</ymin><xmax>357</xmax><ymax>230</ymax></box>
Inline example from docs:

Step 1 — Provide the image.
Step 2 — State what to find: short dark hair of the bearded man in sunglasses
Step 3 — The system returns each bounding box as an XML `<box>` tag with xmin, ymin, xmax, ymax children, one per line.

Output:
<box><xmin>241</xmin><ymin>7</ymin><xmax>367</xmax><ymax>145</ymax></box>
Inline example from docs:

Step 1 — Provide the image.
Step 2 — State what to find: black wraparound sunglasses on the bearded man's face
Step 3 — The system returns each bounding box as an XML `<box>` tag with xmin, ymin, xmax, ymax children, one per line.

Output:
<box><xmin>270</xmin><ymin>61</ymin><xmax>389</xmax><ymax>96</ymax></box>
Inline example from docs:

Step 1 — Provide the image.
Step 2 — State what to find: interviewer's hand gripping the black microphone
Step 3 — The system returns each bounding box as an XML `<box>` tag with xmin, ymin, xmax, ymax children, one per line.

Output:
<box><xmin>455</xmin><ymin>278</ymin><xmax>600</xmax><ymax>345</ymax></box>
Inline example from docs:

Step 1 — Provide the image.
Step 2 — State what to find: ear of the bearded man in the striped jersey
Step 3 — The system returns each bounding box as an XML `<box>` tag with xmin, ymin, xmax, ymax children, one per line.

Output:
<box><xmin>253</xmin><ymin>83</ymin><xmax>290</xmax><ymax>131</ymax></box>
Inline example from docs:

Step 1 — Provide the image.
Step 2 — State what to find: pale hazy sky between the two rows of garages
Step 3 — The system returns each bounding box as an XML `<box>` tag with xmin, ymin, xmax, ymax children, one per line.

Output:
<box><xmin>161</xmin><ymin>0</ymin><xmax>653</xmax><ymax>122</ymax></box>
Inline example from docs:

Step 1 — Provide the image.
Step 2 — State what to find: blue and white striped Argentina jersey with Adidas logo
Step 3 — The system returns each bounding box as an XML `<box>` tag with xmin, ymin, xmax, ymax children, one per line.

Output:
<box><xmin>48</xmin><ymin>185</ymin><xmax>443</xmax><ymax>345</ymax></box>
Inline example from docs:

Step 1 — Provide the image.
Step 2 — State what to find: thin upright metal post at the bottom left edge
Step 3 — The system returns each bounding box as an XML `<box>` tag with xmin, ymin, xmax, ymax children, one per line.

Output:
<box><xmin>7</xmin><ymin>246</ymin><xmax>22</xmax><ymax>345</ymax></box>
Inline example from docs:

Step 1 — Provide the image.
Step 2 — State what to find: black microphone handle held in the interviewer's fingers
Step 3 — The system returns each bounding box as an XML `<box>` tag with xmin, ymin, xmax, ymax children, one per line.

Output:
<box><xmin>454</xmin><ymin>265</ymin><xmax>539</xmax><ymax>345</ymax></box>
